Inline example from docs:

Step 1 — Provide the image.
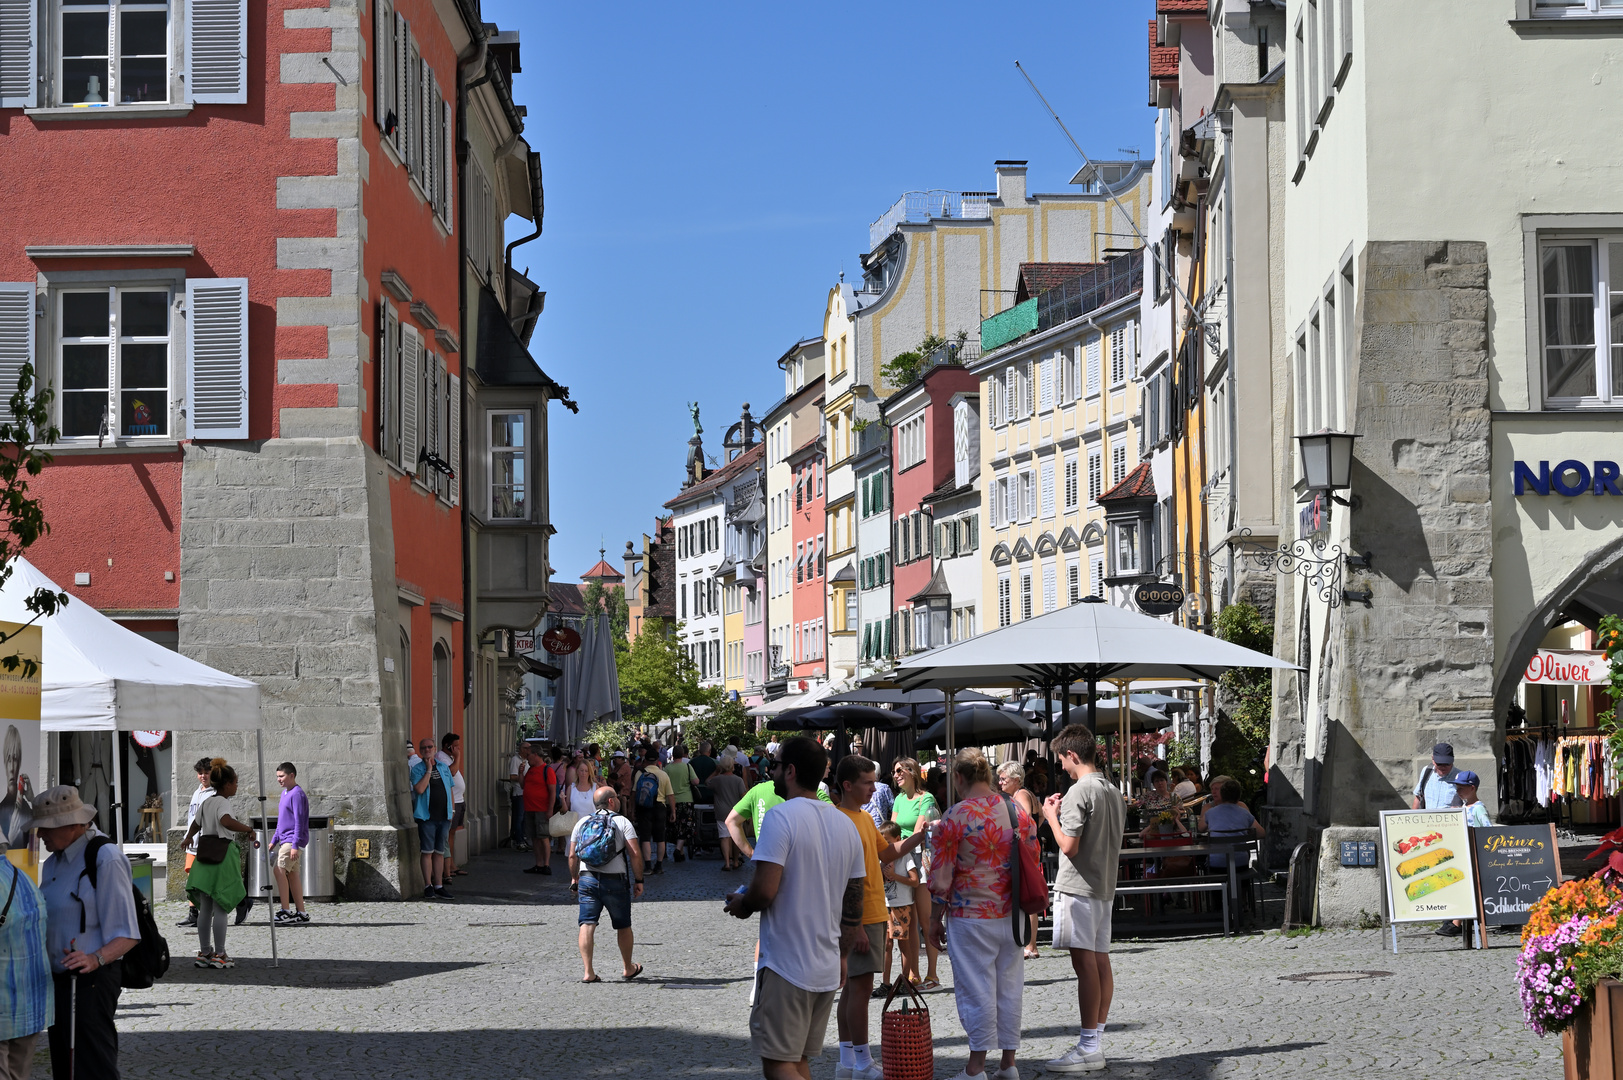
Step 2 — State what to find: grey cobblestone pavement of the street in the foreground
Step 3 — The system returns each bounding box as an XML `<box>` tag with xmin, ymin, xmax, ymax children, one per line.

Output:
<box><xmin>73</xmin><ymin>851</ymin><xmax>1561</xmax><ymax>1080</ymax></box>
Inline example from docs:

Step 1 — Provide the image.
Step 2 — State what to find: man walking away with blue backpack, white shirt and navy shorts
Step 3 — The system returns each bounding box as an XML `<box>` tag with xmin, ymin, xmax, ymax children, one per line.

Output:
<box><xmin>568</xmin><ymin>788</ymin><xmax>643</xmax><ymax>983</ymax></box>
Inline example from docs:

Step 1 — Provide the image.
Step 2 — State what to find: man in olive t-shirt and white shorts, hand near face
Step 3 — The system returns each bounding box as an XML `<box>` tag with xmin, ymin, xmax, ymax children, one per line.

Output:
<box><xmin>1042</xmin><ymin>724</ymin><xmax>1126</xmax><ymax>1072</ymax></box>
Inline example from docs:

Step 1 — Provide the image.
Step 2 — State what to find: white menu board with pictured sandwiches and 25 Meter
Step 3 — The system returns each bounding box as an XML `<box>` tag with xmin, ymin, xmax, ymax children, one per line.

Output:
<box><xmin>1381</xmin><ymin>810</ymin><xmax>1477</xmax><ymax>922</ymax></box>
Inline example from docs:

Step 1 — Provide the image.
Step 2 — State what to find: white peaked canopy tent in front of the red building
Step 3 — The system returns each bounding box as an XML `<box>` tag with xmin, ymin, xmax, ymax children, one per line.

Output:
<box><xmin>0</xmin><ymin>555</ymin><xmax>276</xmax><ymax>960</ymax></box>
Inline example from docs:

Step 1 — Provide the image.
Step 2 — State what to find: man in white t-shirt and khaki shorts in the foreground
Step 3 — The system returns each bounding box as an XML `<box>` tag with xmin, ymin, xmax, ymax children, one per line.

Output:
<box><xmin>727</xmin><ymin>736</ymin><xmax>867</xmax><ymax>1080</ymax></box>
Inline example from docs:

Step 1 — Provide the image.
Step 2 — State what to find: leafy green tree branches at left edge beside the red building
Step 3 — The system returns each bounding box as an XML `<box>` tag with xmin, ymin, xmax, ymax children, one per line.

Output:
<box><xmin>0</xmin><ymin>364</ymin><xmax>68</xmax><ymax>679</ymax></box>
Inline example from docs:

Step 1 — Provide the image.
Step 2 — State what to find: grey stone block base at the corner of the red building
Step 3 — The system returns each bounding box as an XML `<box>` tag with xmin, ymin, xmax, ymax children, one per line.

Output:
<box><xmin>170</xmin><ymin>438</ymin><xmax>415</xmax><ymax>900</ymax></box>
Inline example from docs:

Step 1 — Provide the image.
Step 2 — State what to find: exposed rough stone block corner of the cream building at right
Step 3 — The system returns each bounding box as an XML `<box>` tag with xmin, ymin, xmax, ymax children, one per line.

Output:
<box><xmin>1324</xmin><ymin>240</ymin><xmax>1496</xmax><ymax>825</ymax></box>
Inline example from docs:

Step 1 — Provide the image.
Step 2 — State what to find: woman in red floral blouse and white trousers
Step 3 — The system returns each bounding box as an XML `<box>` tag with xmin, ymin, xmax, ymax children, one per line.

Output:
<box><xmin>930</xmin><ymin>750</ymin><xmax>1037</xmax><ymax>1078</ymax></box>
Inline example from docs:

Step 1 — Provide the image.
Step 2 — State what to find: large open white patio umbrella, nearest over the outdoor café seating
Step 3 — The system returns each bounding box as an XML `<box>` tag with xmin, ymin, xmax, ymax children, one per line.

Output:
<box><xmin>891</xmin><ymin>596</ymin><xmax>1297</xmax><ymax>795</ymax></box>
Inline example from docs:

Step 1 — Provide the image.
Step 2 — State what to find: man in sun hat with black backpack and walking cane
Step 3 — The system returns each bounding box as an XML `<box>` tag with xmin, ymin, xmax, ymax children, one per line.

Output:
<box><xmin>32</xmin><ymin>784</ymin><xmax>141</xmax><ymax>1080</ymax></box>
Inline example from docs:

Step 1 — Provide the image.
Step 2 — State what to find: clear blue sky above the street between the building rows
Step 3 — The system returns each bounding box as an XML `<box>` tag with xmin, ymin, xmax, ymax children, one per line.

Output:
<box><xmin>482</xmin><ymin>0</ymin><xmax>1154</xmax><ymax>581</ymax></box>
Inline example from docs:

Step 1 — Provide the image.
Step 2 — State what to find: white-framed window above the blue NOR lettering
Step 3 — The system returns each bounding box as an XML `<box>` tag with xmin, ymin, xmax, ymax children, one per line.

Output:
<box><xmin>1539</xmin><ymin>234</ymin><xmax>1623</xmax><ymax>408</ymax></box>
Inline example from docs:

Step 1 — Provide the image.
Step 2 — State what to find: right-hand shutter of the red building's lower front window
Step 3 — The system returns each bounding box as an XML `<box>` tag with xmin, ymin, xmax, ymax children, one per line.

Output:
<box><xmin>187</xmin><ymin>278</ymin><xmax>248</xmax><ymax>438</ymax></box>
